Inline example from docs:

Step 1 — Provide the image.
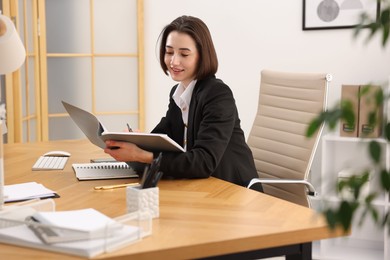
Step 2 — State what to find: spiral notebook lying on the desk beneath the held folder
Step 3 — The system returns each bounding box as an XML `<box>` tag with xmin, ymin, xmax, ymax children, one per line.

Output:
<box><xmin>72</xmin><ymin>162</ymin><xmax>139</xmax><ymax>180</ymax></box>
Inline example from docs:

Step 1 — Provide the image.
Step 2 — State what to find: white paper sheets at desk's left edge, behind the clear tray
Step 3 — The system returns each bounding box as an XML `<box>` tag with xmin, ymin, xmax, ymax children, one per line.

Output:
<box><xmin>4</xmin><ymin>182</ymin><xmax>58</xmax><ymax>202</ymax></box>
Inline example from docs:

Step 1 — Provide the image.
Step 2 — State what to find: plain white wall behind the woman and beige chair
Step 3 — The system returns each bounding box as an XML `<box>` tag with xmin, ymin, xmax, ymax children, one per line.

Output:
<box><xmin>145</xmin><ymin>0</ymin><xmax>390</xmax><ymax>136</ymax></box>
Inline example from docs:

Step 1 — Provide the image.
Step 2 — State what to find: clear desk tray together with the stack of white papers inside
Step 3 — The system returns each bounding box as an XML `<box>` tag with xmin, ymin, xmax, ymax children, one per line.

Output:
<box><xmin>0</xmin><ymin>199</ymin><xmax>152</xmax><ymax>258</ymax></box>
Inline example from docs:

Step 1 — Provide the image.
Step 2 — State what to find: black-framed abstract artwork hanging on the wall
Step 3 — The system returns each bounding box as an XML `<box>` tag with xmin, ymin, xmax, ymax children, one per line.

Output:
<box><xmin>302</xmin><ymin>0</ymin><xmax>380</xmax><ymax>30</ymax></box>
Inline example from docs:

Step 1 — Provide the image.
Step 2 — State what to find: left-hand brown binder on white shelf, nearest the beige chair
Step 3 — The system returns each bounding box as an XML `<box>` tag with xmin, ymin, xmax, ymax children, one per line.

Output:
<box><xmin>340</xmin><ymin>85</ymin><xmax>360</xmax><ymax>137</ymax></box>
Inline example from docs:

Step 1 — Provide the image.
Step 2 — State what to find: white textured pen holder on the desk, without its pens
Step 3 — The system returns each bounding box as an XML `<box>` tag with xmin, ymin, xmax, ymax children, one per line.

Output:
<box><xmin>126</xmin><ymin>186</ymin><xmax>160</xmax><ymax>218</ymax></box>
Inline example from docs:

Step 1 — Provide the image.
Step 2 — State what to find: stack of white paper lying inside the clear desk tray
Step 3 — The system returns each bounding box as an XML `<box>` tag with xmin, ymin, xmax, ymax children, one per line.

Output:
<box><xmin>0</xmin><ymin>209</ymin><xmax>141</xmax><ymax>257</ymax></box>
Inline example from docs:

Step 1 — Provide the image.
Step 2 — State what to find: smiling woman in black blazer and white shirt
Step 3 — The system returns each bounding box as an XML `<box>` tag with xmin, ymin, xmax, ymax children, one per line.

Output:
<box><xmin>105</xmin><ymin>16</ymin><xmax>261</xmax><ymax>190</ymax></box>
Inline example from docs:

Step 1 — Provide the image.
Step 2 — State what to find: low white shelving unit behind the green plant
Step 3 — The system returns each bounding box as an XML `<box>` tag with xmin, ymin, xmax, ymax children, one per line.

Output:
<box><xmin>312</xmin><ymin>135</ymin><xmax>390</xmax><ymax>260</ymax></box>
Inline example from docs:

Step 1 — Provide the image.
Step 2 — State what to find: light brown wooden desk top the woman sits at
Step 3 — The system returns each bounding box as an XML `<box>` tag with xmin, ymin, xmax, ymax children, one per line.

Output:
<box><xmin>0</xmin><ymin>141</ymin><xmax>341</xmax><ymax>260</ymax></box>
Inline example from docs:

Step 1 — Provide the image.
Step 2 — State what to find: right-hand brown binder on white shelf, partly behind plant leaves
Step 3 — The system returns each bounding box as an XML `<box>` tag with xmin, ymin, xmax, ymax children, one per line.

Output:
<box><xmin>358</xmin><ymin>85</ymin><xmax>383</xmax><ymax>138</ymax></box>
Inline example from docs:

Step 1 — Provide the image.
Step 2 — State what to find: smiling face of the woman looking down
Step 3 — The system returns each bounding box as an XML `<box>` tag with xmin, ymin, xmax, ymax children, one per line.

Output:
<box><xmin>164</xmin><ymin>31</ymin><xmax>199</xmax><ymax>86</ymax></box>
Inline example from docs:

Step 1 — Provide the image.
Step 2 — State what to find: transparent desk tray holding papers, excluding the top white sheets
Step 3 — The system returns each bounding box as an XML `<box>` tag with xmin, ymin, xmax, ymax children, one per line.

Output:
<box><xmin>0</xmin><ymin>199</ymin><xmax>152</xmax><ymax>258</ymax></box>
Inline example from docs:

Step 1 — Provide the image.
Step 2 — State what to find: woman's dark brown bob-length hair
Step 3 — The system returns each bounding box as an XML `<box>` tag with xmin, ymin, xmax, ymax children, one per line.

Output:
<box><xmin>160</xmin><ymin>15</ymin><xmax>218</xmax><ymax>79</ymax></box>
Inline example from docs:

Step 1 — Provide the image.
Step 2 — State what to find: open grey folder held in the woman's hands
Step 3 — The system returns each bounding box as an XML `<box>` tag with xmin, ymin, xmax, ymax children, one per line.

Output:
<box><xmin>62</xmin><ymin>101</ymin><xmax>184</xmax><ymax>152</ymax></box>
